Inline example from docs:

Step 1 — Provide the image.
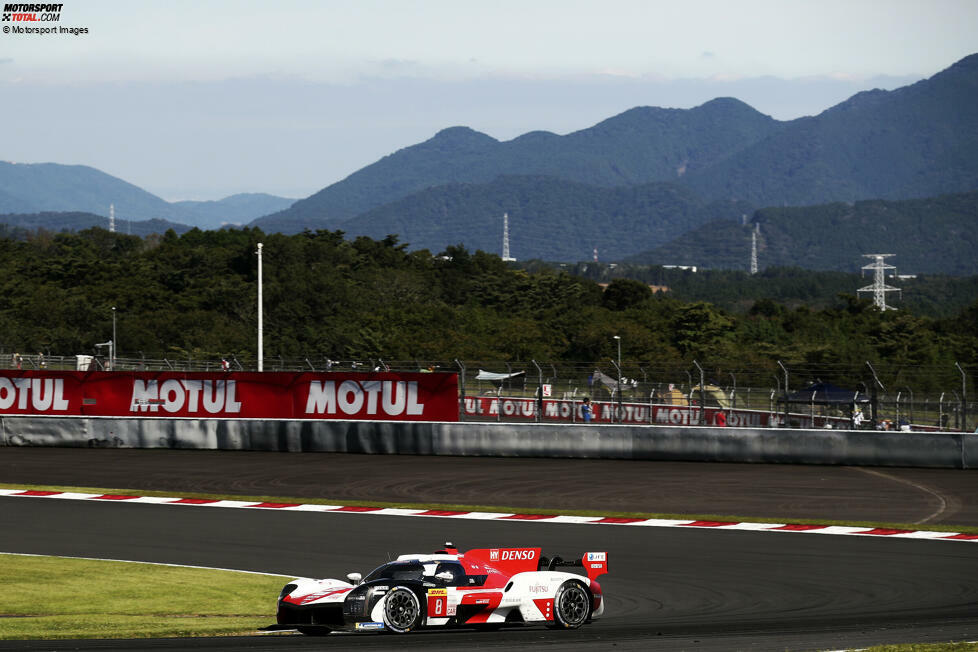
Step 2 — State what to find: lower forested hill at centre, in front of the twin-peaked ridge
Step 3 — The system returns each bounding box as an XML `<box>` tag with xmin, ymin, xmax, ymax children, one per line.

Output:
<box><xmin>341</xmin><ymin>176</ymin><xmax>751</xmax><ymax>261</ymax></box>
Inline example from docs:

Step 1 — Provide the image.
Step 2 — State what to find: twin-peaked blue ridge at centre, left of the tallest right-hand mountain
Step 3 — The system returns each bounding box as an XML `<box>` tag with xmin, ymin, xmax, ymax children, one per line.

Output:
<box><xmin>255</xmin><ymin>98</ymin><xmax>779</xmax><ymax>230</ymax></box>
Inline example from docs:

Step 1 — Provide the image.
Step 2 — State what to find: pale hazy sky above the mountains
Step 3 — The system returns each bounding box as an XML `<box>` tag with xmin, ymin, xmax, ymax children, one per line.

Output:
<box><xmin>0</xmin><ymin>0</ymin><xmax>978</xmax><ymax>200</ymax></box>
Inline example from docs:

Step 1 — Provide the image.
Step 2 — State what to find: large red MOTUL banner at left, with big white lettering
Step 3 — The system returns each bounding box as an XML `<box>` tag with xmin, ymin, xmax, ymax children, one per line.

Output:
<box><xmin>0</xmin><ymin>371</ymin><xmax>458</xmax><ymax>421</ymax></box>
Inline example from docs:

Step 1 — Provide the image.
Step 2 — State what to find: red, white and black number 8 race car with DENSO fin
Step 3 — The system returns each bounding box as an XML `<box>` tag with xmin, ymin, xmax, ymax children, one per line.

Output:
<box><xmin>276</xmin><ymin>542</ymin><xmax>608</xmax><ymax>636</ymax></box>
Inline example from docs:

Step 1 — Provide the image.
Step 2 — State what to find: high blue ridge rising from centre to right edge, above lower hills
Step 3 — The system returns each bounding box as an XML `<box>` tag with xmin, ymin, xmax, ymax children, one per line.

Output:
<box><xmin>253</xmin><ymin>55</ymin><xmax>978</xmax><ymax>237</ymax></box>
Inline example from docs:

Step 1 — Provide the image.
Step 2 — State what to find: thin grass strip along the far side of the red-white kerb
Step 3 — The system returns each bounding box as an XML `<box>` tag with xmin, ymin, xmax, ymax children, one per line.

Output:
<box><xmin>0</xmin><ymin>483</ymin><xmax>978</xmax><ymax>534</ymax></box>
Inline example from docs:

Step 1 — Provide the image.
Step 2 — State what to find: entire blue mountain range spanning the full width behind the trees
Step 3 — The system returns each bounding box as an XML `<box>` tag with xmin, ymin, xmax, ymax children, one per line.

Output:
<box><xmin>0</xmin><ymin>55</ymin><xmax>978</xmax><ymax>273</ymax></box>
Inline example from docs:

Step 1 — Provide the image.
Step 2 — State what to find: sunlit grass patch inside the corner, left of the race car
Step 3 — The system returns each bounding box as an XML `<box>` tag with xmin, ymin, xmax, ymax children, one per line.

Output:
<box><xmin>0</xmin><ymin>554</ymin><xmax>287</xmax><ymax>640</ymax></box>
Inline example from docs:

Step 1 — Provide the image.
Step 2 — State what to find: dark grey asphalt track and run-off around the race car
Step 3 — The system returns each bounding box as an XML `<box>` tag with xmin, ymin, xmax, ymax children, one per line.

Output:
<box><xmin>0</xmin><ymin>448</ymin><xmax>978</xmax><ymax>650</ymax></box>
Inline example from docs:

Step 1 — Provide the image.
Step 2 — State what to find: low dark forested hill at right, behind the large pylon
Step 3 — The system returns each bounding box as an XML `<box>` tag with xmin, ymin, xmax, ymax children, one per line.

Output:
<box><xmin>628</xmin><ymin>192</ymin><xmax>978</xmax><ymax>275</ymax></box>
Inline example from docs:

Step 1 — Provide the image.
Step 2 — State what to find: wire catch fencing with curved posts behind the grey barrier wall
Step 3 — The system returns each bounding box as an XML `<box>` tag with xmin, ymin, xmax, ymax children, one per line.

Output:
<box><xmin>0</xmin><ymin>351</ymin><xmax>978</xmax><ymax>432</ymax></box>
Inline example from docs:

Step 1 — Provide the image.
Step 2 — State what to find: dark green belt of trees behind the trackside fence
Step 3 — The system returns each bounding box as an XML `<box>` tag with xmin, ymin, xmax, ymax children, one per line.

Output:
<box><xmin>0</xmin><ymin>229</ymin><xmax>978</xmax><ymax>387</ymax></box>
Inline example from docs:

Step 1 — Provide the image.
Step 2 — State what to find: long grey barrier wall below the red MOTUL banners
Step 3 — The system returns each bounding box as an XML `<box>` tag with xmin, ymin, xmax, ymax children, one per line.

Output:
<box><xmin>0</xmin><ymin>416</ymin><xmax>978</xmax><ymax>468</ymax></box>
